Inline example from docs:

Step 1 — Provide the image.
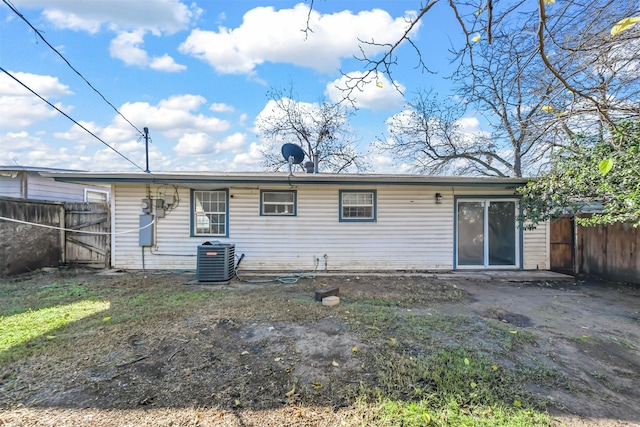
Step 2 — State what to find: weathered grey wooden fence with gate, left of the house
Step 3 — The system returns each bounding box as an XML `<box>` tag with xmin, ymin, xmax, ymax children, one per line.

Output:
<box><xmin>0</xmin><ymin>197</ymin><xmax>111</xmax><ymax>275</ymax></box>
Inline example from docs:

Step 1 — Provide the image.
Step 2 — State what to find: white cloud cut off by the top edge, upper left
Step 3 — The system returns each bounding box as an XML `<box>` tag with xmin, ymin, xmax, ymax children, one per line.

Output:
<box><xmin>13</xmin><ymin>0</ymin><xmax>202</xmax><ymax>34</ymax></box>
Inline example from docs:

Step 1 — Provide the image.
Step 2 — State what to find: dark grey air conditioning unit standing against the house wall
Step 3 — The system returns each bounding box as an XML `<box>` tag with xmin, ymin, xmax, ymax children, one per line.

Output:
<box><xmin>196</xmin><ymin>242</ymin><xmax>235</xmax><ymax>282</ymax></box>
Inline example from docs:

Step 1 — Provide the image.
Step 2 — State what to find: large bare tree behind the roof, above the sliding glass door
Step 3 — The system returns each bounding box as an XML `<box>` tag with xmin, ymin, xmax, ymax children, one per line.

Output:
<box><xmin>381</xmin><ymin>28</ymin><xmax>564</xmax><ymax>177</ymax></box>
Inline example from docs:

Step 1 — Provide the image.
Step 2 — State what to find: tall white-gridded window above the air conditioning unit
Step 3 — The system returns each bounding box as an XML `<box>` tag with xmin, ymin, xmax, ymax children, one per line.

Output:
<box><xmin>191</xmin><ymin>190</ymin><xmax>229</xmax><ymax>236</ymax></box>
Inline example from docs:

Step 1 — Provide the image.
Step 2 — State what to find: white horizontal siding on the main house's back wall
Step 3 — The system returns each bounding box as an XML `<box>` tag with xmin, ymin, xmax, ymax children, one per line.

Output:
<box><xmin>112</xmin><ymin>184</ymin><xmax>546</xmax><ymax>271</ymax></box>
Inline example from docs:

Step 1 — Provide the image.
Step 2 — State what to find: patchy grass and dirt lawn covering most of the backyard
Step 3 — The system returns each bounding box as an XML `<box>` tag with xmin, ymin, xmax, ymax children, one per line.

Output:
<box><xmin>0</xmin><ymin>274</ymin><xmax>580</xmax><ymax>426</ymax></box>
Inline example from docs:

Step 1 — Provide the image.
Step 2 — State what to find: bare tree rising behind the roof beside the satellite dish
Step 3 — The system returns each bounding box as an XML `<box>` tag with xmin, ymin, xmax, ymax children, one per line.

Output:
<box><xmin>257</xmin><ymin>87</ymin><xmax>368</xmax><ymax>173</ymax></box>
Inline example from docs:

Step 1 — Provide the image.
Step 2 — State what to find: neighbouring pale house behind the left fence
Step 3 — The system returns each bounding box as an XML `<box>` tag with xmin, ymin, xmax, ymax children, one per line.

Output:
<box><xmin>0</xmin><ymin>166</ymin><xmax>109</xmax><ymax>203</ymax></box>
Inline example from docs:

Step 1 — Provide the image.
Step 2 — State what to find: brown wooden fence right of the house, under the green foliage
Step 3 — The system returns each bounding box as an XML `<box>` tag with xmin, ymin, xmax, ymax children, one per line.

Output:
<box><xmin>550</xmin><ymin>217</ymin><xmax>640</xmax><ymax>284</ymax></box>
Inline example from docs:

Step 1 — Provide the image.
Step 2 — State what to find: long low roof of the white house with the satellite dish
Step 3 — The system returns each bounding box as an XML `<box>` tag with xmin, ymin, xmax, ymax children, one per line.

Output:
<box><xmin>41</xmin><ymin>172</ymin><xmax>529</xmax><ymax>187</ymax></box>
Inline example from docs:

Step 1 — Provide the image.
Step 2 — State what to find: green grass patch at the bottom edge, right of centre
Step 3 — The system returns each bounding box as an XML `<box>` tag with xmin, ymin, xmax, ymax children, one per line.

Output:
<box><xmin>357</xmin><ymin>346</ymin><xmax>552</xmax><ymax>426</ymax></box>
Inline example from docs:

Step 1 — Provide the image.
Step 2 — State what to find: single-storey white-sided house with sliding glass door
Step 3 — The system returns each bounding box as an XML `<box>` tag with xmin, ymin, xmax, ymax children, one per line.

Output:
<box><xmin>44</xmin><ymin>172</ymin><xmax>549</xmax><ymax>271</ymax></box>
